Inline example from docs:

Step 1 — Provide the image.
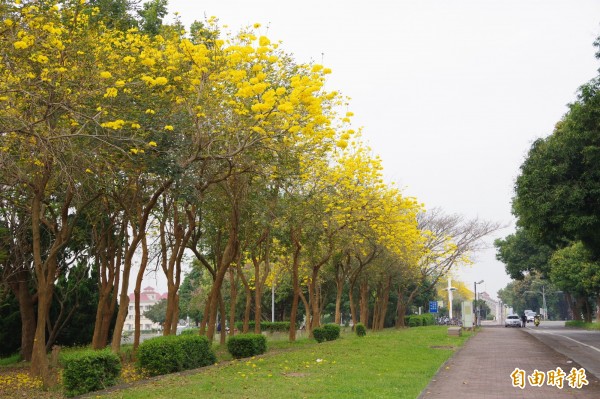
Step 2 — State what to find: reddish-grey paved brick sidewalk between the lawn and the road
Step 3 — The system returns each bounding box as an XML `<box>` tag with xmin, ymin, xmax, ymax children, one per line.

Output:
<box><xmin>419</xmin><ymin>326</ymin><xmax>600</xmax><ymax>399</ymax></box>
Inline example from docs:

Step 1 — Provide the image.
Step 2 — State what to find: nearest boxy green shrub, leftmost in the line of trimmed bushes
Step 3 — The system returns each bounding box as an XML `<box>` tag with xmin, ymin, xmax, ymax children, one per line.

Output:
<box><xmin>62</xmin><ymin>349</ymin><xmax>121</xmax><ymax>397</ymax></box>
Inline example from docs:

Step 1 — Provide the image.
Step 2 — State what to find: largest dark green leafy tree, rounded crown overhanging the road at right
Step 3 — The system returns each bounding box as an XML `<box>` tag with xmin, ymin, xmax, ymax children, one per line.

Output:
<box><xmin>513</xmin><ymin>75</ymin><xmax>600</xmax><ymax>259</ymax></box>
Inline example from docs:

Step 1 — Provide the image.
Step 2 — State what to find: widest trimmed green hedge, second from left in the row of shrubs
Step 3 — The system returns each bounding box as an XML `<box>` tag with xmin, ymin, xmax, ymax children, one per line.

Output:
<box><xmin>137</xmin><ymin>335</ymin><xmax>217</xmax><ymax>376</ymax></box>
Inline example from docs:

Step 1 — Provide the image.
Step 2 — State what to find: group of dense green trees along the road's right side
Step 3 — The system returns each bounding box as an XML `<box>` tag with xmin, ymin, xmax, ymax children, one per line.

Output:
<box><xmin>496</xmin><ymin>36</ymin><xmax>600</xmax><ymax>321</ymax></box>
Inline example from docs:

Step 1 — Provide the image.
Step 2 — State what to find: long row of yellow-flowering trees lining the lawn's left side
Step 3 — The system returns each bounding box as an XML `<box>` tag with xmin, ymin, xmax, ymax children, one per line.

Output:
<box><xmin>0</xmin><ymin>0</ymin><xmax>498</xmax><ymax>388</ymax></box>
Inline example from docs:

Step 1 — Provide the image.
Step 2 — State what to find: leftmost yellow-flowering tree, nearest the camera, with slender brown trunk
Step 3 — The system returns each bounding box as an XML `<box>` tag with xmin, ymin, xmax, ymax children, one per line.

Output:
<box><xmin>0</xmin><ymin>1</ymin><xmax>166</xmax><ymax>379</ymax></box>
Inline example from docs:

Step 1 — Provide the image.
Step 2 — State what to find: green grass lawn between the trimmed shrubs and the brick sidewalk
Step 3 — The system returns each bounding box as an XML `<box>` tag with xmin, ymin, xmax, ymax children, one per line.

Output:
<box><xmin>101</xmin><ymin>326</ymin><xmax>469</xmax><ymax>399</ymax></box>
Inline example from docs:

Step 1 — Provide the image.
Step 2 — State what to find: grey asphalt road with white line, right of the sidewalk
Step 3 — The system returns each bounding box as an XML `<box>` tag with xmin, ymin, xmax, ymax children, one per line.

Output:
<box><xmin>525</xmin><ymin>321</ymin><xmax>600</xmax><ymax>378</ymax></box>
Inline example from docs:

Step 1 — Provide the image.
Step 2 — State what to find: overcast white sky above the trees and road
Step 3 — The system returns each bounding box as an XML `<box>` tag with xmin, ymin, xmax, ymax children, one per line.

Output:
<box><xmin>148</xmin><ymin>0</ymin><xmax>600</xmax><ymax>297</ymax></box>
